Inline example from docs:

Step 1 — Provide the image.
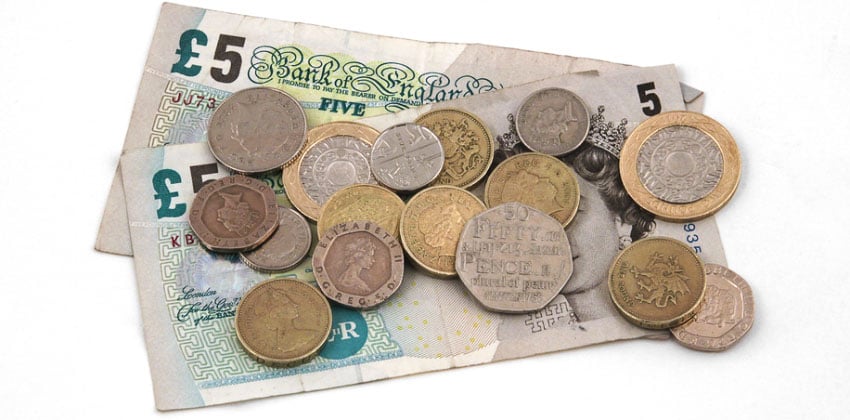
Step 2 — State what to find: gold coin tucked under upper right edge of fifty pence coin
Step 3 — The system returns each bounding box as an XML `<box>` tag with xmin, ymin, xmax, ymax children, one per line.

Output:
<box><xmin>484</xmin><ymin>153</ymin><xmax>581</xmax><ymax>226</ymax></box>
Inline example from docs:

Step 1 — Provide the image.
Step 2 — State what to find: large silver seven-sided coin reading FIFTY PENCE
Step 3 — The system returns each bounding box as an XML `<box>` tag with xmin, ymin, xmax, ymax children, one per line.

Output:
<box><xmin>455</xmin><ymin>202</ymin><xmax>573</xmax><ymax>313</ymax></box>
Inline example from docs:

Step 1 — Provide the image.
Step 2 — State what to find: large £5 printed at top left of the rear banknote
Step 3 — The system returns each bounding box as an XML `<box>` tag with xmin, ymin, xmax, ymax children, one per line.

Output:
<box><xmin>171</xmin><ymin>29</ymin><xmax>245</xmax><ymax>83</ymax></box>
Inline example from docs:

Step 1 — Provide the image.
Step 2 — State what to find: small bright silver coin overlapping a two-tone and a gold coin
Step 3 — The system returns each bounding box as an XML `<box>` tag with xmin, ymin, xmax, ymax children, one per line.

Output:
<box><xmin>371</xmin><ymin>123</ymin><xmax>445</xmax><ymax>191</ymax></box>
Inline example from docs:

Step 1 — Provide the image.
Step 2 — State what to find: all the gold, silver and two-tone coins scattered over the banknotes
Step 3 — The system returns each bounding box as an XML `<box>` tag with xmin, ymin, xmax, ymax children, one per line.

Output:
<box><xmin>189</xmin><ymin>88</ymin><xmax>753</xmax><ymax>366</ymax></box>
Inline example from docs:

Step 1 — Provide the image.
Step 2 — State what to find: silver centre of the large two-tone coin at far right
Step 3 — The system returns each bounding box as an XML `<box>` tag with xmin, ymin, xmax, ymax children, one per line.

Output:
<box><xmin>637</xmin><ymin>125</ymin><xmax>723</xmax><ymax>204</ymax></box>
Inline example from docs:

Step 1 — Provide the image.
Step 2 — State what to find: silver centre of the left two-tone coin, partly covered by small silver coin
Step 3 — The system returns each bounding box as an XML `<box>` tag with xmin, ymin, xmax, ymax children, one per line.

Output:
<box><xmin>298</xmin><ymin>135</ymin><xmax>378</xmax><ymax>206</ymax></box>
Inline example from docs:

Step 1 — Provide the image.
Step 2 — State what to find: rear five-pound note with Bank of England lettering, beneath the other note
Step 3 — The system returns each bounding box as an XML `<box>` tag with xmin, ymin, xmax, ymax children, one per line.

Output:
<box><xmin>95</xmin><ymin>3</ymin><xmax>702</xmax><ymax>255</ymax></box>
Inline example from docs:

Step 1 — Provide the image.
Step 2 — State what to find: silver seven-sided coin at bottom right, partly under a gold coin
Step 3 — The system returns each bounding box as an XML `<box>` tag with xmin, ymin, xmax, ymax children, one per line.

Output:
<box><xmin>671</xmin><ymin>264</ymin><xmax>755</xmax><ymax>351</ymax></box>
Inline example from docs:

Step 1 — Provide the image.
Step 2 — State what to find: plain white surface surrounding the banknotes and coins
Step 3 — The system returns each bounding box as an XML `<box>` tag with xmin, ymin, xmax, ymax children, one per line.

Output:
<box><xmin>0</xmin><ymin>0</ymin><xmax>850</xmax><ymax>419</ymax></box>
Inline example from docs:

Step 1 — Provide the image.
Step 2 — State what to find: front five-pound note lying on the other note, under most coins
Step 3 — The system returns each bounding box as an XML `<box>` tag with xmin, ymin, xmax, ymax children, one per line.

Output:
<box><xmin>121</xmin><ymin>67</ymin><xmax>725</xmax><ymax>410</ymax></box>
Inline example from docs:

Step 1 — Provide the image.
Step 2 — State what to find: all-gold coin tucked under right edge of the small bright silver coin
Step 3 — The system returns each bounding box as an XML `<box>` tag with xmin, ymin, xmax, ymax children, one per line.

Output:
<box><xmin>416</xmin><ymin>109</ymin><xmax>496</xmax><ymax>188</ymax></box>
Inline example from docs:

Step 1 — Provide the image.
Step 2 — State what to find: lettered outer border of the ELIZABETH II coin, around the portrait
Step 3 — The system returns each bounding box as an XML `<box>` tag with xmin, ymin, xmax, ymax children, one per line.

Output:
<box><xmin>313</xmin><ymin>220</ymin><xmax>404</xmax><ymax>309</ymax></box>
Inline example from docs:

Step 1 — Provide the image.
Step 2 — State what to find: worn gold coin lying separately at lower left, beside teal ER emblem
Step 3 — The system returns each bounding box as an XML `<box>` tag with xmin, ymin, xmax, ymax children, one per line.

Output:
<box><xmin>234</xmin><ymin>279</ymin><xmax>332</xmax><ymax>367</ymax></box>
